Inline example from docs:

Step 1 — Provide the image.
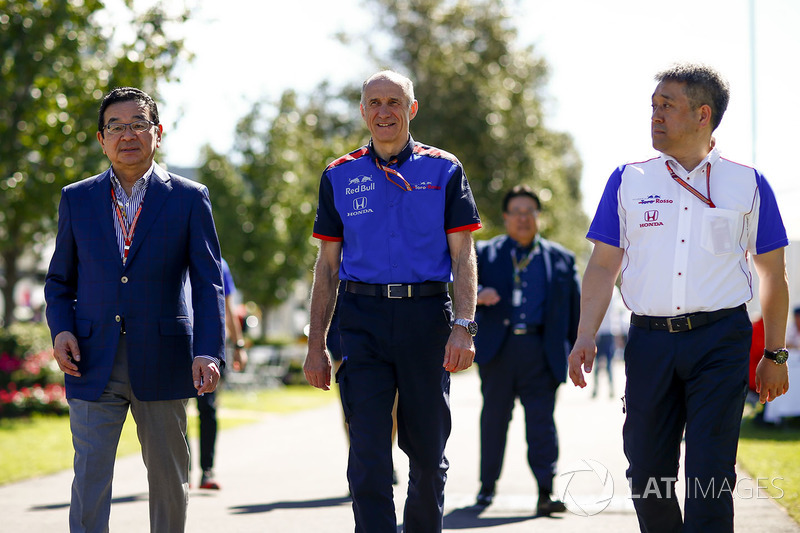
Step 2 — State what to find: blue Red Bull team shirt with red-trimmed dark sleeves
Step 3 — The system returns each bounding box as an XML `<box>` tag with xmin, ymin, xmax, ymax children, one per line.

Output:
<box><xmin>313</xmin><ymin>136</ymin><xmax>481</xmax><ymax>284</ymax></box>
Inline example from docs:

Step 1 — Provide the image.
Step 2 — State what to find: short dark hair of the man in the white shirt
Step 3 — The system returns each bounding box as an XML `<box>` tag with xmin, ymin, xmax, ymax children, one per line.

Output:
<box><xmin>655</xmin><ymin>63</ymin><xmax>730</xmax><ymax>131</ymax></box>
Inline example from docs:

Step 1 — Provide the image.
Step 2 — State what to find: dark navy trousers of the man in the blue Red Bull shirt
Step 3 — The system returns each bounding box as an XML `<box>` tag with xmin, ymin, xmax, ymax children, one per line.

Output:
<box><xmin>336</xmin><ymin>293</ymin><xmax>453</xmax><ymax>533</ymax></box>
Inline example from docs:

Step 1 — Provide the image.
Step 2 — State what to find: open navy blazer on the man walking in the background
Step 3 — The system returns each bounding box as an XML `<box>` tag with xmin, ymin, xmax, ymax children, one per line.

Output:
<box><xmin>475</xmin><ymin>235</ymin><xmax>580</xmax><ymax>383</ymax></box>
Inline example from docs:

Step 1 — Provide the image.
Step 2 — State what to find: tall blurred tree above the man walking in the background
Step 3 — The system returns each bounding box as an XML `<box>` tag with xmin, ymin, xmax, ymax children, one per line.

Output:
<box><xmin>373</xmin><ymin>0</ymin><xmax>588</xmax><ymax>250</ymax></box>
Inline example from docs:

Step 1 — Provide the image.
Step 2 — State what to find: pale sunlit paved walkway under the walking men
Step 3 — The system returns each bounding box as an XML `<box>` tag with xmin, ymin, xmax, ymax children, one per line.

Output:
<box><xmin>0</xmin><ymin>366</ymin><xmax>800</xmax><ymax>533</ymax></box>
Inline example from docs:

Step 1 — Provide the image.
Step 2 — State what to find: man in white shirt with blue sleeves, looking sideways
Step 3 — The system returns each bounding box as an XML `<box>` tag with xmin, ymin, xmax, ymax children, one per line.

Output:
<box><xmin>569</xmin><ymin>64</ymin><xmax>789</xmax><ymax>533</ymax></box>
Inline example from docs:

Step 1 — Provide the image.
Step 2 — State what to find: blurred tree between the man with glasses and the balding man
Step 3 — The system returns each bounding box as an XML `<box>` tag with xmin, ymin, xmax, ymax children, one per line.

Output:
<box><xmin>198</xmin><ymin>84</ymin><xmax>366</xmax><ymax>316</ymax></box>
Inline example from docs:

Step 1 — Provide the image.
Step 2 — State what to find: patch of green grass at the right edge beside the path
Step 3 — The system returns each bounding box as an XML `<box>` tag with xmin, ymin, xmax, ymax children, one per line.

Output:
<box><xmin>738</xmin><ymin>415</ymin><xmax>800</xmax><ymax>522</ymax></box>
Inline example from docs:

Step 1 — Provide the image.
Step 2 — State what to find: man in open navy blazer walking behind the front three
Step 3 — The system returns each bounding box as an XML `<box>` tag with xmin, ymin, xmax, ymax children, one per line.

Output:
<box><xmin>475</xmin><ymin>185</ymin><xmax>580</xmax><ymax>515</ymax></box>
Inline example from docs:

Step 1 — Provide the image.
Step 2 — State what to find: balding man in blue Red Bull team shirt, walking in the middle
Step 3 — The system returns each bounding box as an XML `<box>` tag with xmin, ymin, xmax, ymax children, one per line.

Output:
<box><xmin>304</xmin><ymin>71</ymin><xmax>481</xmax><ymax>533</ymax></box>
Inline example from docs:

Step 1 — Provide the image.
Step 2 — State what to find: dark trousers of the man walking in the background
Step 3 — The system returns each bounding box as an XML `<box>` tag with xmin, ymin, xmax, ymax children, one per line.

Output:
<box><xmin>479</xmin><ymin>334</ymin><xmax>559</xmax><ymax>495</ymax></box>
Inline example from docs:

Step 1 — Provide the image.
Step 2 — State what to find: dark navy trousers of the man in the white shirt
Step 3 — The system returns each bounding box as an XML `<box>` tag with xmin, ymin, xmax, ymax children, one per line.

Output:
<box><xmin>622</xmin><ymin>310</ymin><xmax>752</xmax><ymax>533</ymax></box>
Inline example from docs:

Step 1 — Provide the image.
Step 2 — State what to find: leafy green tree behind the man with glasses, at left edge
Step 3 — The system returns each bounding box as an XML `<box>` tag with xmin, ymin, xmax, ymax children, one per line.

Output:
<box><xmin>0</xmin><ymin>0</ymin><xmax>189</xmax><ymax>324</ymax></box>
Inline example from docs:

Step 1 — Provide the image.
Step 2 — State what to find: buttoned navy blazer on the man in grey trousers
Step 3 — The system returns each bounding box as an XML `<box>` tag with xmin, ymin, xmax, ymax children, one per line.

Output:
<box><xmin>45</xmin><ymin>165</ymin><xmax>225</xmax><ymax>401</ymax></box>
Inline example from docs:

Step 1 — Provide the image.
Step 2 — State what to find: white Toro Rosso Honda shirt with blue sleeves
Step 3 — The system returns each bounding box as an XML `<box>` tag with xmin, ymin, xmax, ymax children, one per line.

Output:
<box><xmin>586</xmin><ymin>149</ymin><xmax>789</xmax><ymax>316</ymax></box>
